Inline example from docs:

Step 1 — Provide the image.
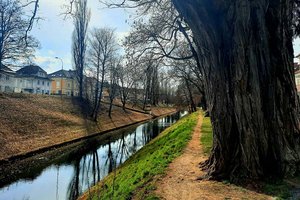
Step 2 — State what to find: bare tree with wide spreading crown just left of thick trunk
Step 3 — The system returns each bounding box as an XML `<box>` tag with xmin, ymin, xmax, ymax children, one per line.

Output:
<box><xmin>124</xmin><ymin>1</ymin><xmax>204</xmax><ymax>110</ymax></box>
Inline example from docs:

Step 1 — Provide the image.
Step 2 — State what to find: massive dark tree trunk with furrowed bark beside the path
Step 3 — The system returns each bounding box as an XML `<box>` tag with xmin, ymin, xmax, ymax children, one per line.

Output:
<box><xmin>172</xmin><ymin>0</ymin><xmax>300</xmax><ymax>181</ymax></box>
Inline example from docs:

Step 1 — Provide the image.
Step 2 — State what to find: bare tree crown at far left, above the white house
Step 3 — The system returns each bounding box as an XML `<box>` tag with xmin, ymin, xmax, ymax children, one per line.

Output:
<box><xmin>0</xmin><ymin>0</ymin><xmax>39</xmax><ymax>68</ymax></box>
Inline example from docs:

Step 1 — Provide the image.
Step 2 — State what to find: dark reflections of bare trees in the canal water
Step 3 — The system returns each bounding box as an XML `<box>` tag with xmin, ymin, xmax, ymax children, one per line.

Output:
<box><xmin>68</xmin><ymin>113</ymin><xmax>185</xmax><ymax>200</ymax></box>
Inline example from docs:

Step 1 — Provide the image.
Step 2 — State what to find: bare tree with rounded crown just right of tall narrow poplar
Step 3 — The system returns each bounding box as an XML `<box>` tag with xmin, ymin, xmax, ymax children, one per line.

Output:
<box><xmin>89</xmin><ymin>28</ymin><xmax>117</xmax><ymax>121</ymax></box>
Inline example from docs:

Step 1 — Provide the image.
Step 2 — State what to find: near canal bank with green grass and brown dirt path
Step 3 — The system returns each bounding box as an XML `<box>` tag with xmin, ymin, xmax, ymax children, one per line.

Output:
<box><xmin>79</xmin><ymin>113</ymin><xmax>300</xmax><ymax>200</ymax></box>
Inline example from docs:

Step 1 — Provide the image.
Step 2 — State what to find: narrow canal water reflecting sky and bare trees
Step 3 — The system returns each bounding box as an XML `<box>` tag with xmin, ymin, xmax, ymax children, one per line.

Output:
<box><xmin>0</xmin><ymin>112</ymin><xmax>187</xmax><ymax>200</ymax></box>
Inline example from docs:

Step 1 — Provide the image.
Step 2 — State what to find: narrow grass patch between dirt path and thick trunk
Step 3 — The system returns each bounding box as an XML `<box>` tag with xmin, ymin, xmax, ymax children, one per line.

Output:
<box><xmin>200</xmin><ymin>117</ymin><xmax>213</xmax><ymax>155</ymax></box>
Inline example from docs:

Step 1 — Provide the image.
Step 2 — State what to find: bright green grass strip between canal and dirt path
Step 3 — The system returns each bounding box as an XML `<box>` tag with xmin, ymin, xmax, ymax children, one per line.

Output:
<box><xmin>81</xmin><ymin>112</ymin><xmax>200</xmax><ymax>200</ymax></box>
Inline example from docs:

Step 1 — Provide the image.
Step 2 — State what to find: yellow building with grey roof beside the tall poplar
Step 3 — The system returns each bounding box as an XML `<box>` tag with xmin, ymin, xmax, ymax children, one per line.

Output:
<box><xmin>49</xmin><ymin>70</ymin><xmax>79</xmax><ymax>96</ymax></box>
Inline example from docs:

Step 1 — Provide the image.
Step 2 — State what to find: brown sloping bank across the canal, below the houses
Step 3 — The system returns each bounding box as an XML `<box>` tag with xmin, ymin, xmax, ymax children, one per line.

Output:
<box><xmin>0</xmin><ymin>94</ymin><xmax>176</xmax><ymax>161</ymax></box>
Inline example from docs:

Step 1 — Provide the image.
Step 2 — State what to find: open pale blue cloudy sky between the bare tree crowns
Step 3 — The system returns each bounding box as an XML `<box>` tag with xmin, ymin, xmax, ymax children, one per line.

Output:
<box><xmin>31</xmin><ymin>0</ymin><xmax>133</xmax><ymax>73</ymax></box>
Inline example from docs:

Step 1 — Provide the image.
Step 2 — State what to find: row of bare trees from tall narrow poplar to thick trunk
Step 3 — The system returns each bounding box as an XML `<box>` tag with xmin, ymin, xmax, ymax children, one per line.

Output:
<box><xmin>72</xmin><ymin>0</ymin><xmax>200</xmax><ymax>121</ymax></box>
